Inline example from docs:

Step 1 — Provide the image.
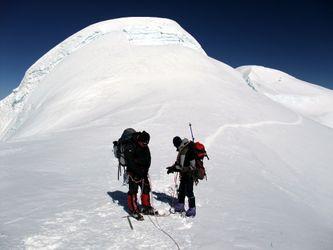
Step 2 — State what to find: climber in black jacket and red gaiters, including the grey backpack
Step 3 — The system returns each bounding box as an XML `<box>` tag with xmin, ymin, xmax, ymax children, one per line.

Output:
<box><xmin>114</xmin><ymin>129</ymin><xmax>155</xmax><ymax>220</ymax></box>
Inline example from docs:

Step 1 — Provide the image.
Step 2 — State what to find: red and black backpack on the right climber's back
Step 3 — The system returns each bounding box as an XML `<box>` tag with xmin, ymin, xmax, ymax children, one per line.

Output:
<box><xmin>192</xmin><ymin>142</ymin><xmax>209</xmax><ymax>183</ymax></box>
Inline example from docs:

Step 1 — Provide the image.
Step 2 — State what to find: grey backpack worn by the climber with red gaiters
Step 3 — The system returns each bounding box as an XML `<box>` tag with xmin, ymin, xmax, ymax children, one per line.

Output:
<box><xmin>113</xmin><ymin>128</ymin><xmax>136</xmax><ymax>180</ymax></box>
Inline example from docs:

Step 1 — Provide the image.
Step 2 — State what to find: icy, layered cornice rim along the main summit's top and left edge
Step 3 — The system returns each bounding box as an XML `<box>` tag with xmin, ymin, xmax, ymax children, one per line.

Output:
<box><xmin>0</xmin><ymin>17</ymin><xmax>206</xmax><ymax>138</ymax></box>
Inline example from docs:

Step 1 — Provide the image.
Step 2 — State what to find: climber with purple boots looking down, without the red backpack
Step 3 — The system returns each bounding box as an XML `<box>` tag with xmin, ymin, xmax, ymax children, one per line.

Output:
<box><xmin>167</xmin><ymin>136</ymin><xmax>196</xmax><ymax>217</ymax></box>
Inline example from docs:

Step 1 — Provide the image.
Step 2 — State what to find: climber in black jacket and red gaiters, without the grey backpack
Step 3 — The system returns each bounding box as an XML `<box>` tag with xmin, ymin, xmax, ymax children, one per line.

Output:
<box><xmin>124</xmin><ymin>131</ymin><xmax>154</xmax><ymax>217</ymax></box>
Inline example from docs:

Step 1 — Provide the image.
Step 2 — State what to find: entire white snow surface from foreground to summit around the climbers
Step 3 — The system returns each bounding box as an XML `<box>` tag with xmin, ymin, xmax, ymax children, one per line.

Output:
<box><xmin>0</xmin><ymin>18</ymin><xmax>333</xmax><ymax>249</ymax></box>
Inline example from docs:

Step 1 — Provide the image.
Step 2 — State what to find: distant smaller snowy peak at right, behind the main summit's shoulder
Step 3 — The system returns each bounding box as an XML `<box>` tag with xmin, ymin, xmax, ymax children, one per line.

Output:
<box><xmin>237</xmin><ymin>66</ymin><xmax>333</xmax><ymax>128</ymax></box>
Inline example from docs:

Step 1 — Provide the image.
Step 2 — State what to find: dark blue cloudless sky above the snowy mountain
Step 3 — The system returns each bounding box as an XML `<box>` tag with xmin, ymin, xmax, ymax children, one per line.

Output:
<box><xmin>0</xmin><ymin>0</ymin><xmax>333</xmax><ymax>99</ymax></box>
